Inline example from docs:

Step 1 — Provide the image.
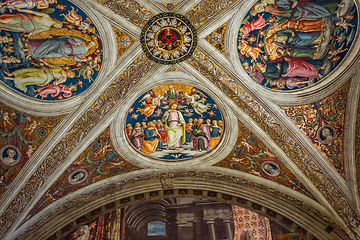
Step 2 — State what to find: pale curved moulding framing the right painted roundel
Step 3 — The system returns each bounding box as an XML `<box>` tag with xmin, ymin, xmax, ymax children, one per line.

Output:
<box><xmin>224</xmin><ymin>0</ymin><xmax>360</xmax><ymax>106</ymax></box>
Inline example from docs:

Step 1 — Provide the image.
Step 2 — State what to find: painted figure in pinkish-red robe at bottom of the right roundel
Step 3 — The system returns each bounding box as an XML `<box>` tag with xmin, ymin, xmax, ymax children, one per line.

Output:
<box><xmin>254</xmin><ymin>56</ymin><xmax>326</xmax><ymax>79</ymax></box>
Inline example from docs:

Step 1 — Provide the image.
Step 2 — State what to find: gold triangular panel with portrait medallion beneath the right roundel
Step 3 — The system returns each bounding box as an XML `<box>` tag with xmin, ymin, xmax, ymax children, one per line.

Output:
<box><xmin>281</xmin><ymin>79</ymin><xmax>350</xmax><ymax>178</ymax></box>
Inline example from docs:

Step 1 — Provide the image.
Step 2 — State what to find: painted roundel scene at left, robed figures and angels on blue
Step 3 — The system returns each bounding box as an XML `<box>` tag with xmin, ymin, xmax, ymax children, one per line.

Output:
<box><xmin>0</xmin><ymin>0</ymin><xmax>102</xmax><ymax>100</ymax></box>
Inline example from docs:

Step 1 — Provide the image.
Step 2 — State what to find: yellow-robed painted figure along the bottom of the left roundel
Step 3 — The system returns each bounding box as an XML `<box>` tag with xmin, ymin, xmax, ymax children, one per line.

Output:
<box><xmin>4</xmin><ymin>64</ymin><xmax>75</xmax><ymax>92</ymax></box>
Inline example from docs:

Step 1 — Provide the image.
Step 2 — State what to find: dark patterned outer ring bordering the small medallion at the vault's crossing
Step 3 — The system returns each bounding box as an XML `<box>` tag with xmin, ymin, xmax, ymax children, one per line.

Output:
<box><xmin>140</xmin><ymin>12</ymin><xmax>197</xmax><ymax>65</ymax></box>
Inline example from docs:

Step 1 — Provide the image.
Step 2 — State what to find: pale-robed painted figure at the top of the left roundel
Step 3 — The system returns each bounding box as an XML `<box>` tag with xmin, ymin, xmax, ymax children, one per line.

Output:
<box><xmin>0</xmin><ymin>9</ymin><xmax>63</xmax><ymax>37</ymax></box>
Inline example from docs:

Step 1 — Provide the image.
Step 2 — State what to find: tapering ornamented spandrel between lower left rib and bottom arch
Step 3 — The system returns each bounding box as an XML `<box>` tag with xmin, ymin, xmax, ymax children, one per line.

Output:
<box><xmin>23</xmin><ymin>127</ymin><xmax>140</xmax><ymax>223</ymax></box>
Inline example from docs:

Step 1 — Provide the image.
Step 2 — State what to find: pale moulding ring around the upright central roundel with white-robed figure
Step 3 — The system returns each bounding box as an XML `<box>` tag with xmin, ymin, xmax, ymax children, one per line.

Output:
<box><xmin>110</xmin><ymin>72</ymin><xmax>238</xmax><ymax>168</ymax></box>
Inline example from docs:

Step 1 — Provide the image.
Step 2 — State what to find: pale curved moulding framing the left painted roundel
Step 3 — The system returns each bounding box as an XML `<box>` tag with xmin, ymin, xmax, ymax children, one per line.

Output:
<box><xmin>0</xmin><ymin>0</ymin><xmax>117</xmax><ymax>116</ymax></box>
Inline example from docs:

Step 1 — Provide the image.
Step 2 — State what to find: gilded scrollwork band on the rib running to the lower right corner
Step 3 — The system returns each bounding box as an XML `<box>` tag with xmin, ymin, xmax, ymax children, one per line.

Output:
<box><xmin>188</xmin><ymin>50</ymin><xmax>360</xmax><ymax>238</ymax></box>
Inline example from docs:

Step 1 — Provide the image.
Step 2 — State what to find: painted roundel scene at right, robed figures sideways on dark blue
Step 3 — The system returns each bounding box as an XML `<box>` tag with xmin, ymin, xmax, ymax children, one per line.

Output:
<box><xmin>238</xmin><ymin>0</ymin><xmax>358</xmax><ymax>90</ymax></box>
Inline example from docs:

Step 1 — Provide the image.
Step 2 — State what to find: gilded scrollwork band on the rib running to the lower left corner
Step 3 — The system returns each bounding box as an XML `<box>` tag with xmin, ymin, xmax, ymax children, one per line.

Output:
<box><xmin>0</xmin><ymin>55</ymin><xmax>155</xmax><ymax>238</ymax></box>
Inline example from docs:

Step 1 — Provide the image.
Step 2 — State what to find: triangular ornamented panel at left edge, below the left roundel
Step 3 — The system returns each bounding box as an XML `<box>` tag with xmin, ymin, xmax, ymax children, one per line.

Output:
<box><xmin>0</xmin><ymin>103</ymin><xmax>64</xmax><ymax>196</ymax></box>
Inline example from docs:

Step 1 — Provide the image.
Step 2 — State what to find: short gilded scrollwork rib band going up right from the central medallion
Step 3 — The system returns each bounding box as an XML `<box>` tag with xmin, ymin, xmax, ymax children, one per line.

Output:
<box><xmin>185</xmin><ymin>0</ymin><xmax>235</xmax><ymax>28</ymax></box>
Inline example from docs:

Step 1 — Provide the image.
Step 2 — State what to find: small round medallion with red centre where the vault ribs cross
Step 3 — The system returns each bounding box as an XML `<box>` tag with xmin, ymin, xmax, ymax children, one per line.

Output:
<box><xmin>140</xmin><ymin>13</ymin><xmax>197</xmax><ymax>64</ymax></box>
